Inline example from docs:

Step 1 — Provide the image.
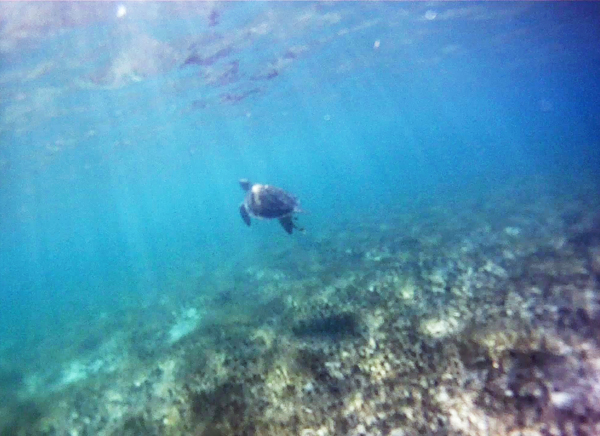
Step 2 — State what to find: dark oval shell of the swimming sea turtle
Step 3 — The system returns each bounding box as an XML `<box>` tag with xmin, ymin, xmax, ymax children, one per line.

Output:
<box><xmin>244</xmin><ymin>184</ymin><xmax>298</xmax><ymax>219</ymax></box>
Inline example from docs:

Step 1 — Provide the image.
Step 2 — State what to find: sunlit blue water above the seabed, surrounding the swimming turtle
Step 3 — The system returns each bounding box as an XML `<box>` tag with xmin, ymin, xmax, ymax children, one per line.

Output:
<box><xmin>0</xmin><ymin>2</ymin><xmax>600</xmax><ymax>424</ymax></box>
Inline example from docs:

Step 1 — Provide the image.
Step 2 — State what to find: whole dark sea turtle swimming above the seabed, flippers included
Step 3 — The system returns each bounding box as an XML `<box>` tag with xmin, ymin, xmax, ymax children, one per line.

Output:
<box><xmin>240</xmin><ymin>179</ymin><xmax>304</xmax><ymax>234</ymax></box>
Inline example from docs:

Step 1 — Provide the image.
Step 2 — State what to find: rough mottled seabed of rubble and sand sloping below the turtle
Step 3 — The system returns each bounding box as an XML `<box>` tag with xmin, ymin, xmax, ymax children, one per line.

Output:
<box><xmin>0</xmin><ymin>177</ymin><xmax>600</xmax><ymax>436</ymax></box>
